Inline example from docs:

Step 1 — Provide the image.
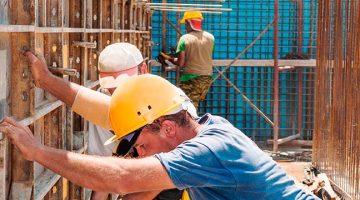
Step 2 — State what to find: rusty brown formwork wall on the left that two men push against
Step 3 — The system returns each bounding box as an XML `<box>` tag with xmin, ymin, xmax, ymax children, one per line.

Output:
<box><xmin>0</xmin><ymin>0</ymin><xmax>152</xmax><ymax>200</ymax></box>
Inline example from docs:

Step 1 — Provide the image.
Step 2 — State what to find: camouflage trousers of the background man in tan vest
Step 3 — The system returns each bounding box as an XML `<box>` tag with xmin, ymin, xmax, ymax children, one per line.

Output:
<box><xmin>179</xmin><ymin>76</ymin><xmax>212</xmax><ymax>109</ymax></box>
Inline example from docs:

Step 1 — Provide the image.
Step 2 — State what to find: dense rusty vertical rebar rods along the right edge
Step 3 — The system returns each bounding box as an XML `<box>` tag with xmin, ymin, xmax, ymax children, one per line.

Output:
<box><xmin>313</xmin><ymin>0</ymin><xmax>360</xmax><ymax>200</ymax></box>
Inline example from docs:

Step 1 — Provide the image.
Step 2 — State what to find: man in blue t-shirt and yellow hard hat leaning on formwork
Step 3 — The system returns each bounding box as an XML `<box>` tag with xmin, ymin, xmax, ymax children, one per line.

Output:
<box><xmin>0</xmin><ymin>71</ymin><xmax>318</xmax><ymax>200</ymax></box>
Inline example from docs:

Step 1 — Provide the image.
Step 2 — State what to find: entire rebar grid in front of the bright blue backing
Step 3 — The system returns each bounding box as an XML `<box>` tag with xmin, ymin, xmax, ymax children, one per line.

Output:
<box><xmin>152</xmin><ymin>0</ymin><xmax>317</xmax><ymax>143</ymax></box>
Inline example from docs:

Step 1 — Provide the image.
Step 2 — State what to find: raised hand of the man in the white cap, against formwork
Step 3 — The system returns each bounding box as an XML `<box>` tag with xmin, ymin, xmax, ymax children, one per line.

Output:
<box><xmin>24</xmin><ymin>51</ymin><xmax>52</xmax><ymax>88</ymax></box>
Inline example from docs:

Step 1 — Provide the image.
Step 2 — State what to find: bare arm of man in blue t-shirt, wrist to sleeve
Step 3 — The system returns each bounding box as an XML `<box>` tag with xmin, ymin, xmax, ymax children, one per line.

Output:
<box><xmin>33</xmin><ymin>145</ymin><xmax>174</xmax><ymax>194</ymax></box>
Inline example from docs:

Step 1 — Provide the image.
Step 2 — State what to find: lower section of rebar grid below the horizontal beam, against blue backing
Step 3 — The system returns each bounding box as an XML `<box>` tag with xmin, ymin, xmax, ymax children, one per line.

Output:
<box><xmin>152</xmin><ymin>66</ymin><xmax>314</xmax><ymax>144</ymax></box>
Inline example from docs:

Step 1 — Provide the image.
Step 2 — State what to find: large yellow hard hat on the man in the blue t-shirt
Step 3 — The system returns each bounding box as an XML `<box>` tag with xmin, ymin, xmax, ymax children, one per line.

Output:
<box><xmin>105</xmin><ymin>74</ymin><xmax>185</xmax><ymax>144</ymax></box>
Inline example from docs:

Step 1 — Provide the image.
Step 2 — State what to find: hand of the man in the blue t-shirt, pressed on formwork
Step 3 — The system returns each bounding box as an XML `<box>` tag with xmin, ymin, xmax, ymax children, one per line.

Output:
<box><xmin>0</xmin><ymin>118</ymin><xmax>42</xmax><ymax>161</ymax></box>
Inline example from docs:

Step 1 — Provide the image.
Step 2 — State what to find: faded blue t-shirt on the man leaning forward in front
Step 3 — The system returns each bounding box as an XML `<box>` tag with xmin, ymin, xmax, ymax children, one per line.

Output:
<box><xmin>155</xmin><ymin>114</ymin><xmax>317</xmax><ymax>200</ymax></box>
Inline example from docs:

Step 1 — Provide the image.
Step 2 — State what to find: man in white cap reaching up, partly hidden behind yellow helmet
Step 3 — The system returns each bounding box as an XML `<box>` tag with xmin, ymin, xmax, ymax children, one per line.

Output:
<box><xmin>18</xmin><ymin>47</ymin><xmax>197</xmax><ymax>200</ymax></box>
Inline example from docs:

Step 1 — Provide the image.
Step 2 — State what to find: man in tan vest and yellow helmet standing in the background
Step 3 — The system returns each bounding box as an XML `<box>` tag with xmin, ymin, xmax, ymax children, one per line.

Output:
<box><xmin>165</xmin><ymin>11</ymin><xmax>215</xmax><ymax>108</ymax></box>
